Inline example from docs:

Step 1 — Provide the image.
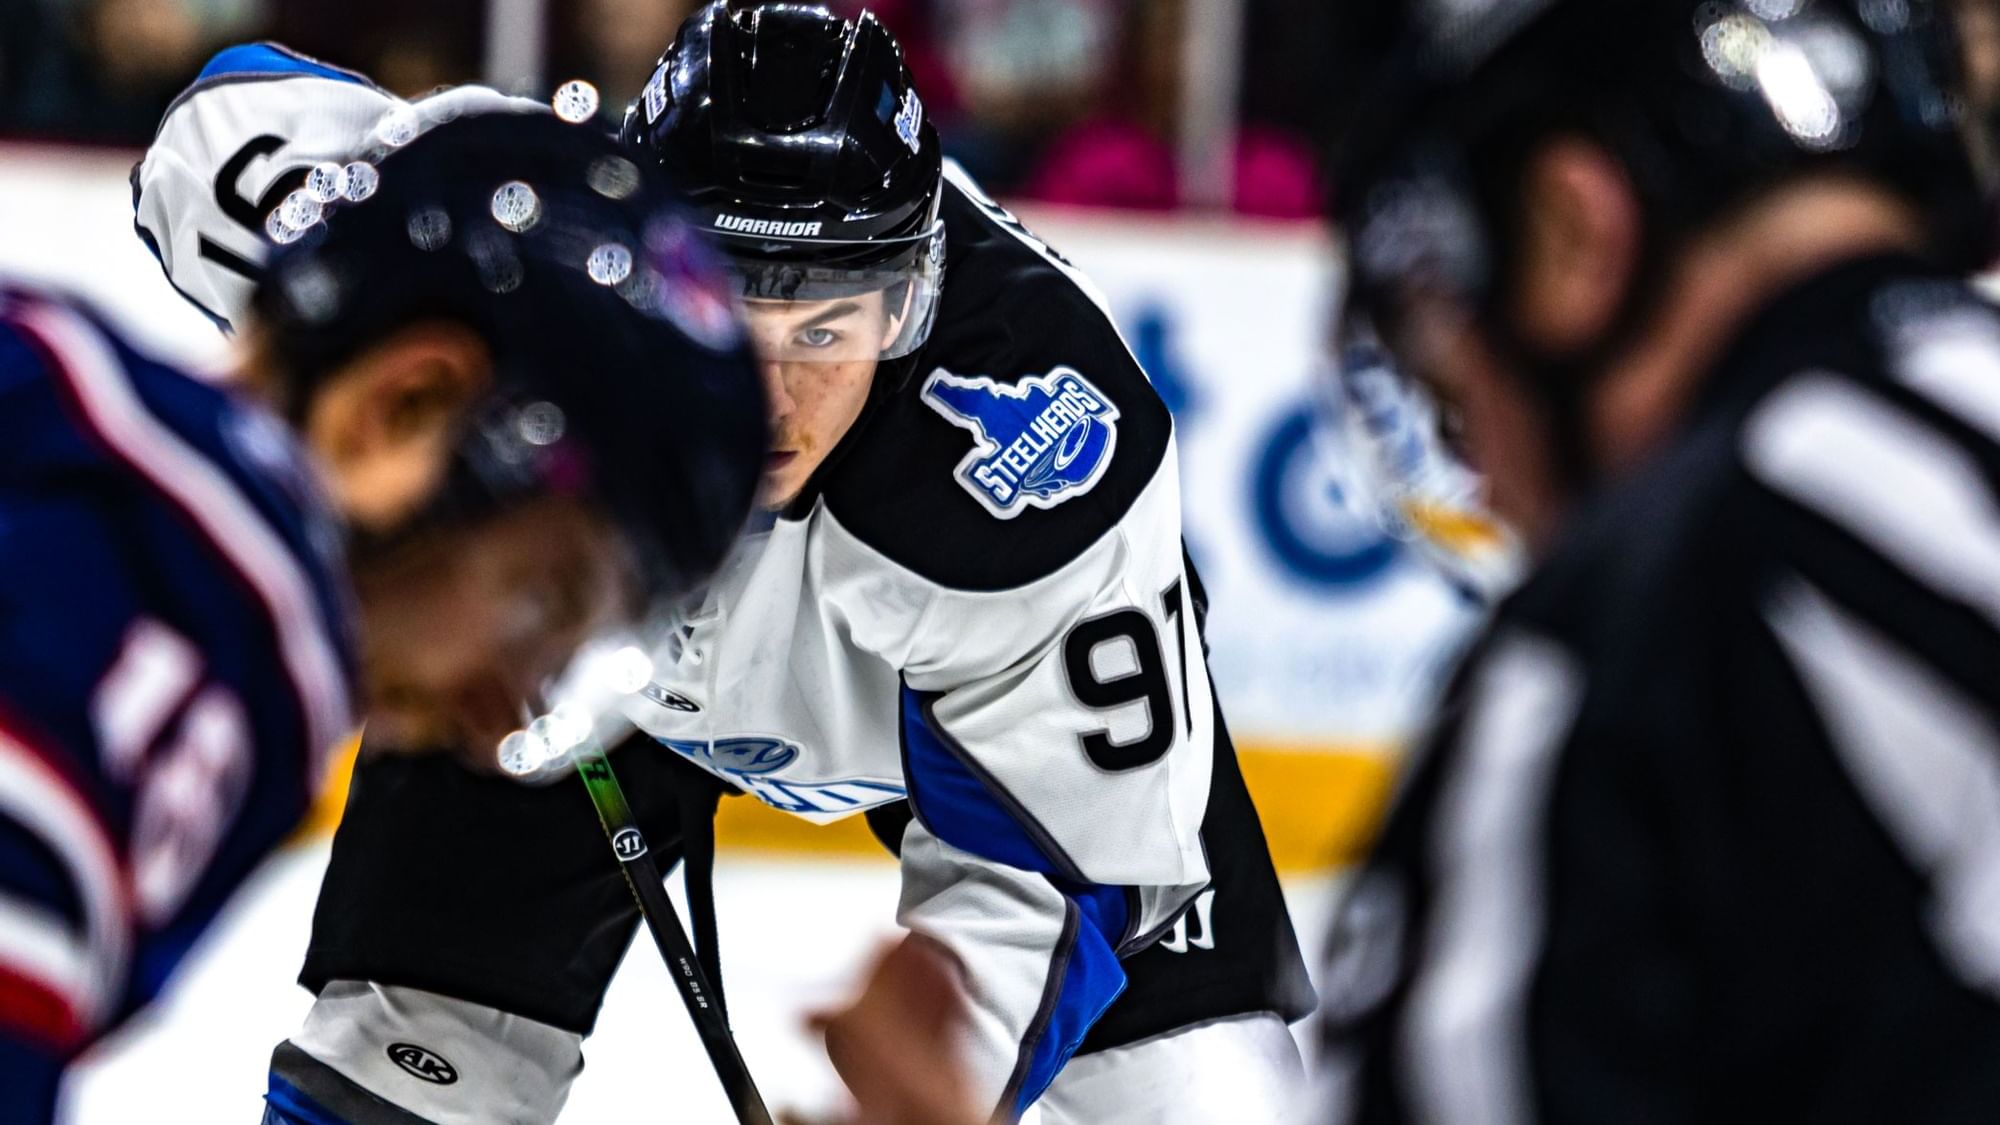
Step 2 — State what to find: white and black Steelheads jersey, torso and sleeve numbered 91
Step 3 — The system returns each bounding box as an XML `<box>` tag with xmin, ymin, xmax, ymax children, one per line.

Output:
<box><xmin>630</xmin><ymin>172</ymin><xmax>1228</xmax><ymax>1109</ymax></box>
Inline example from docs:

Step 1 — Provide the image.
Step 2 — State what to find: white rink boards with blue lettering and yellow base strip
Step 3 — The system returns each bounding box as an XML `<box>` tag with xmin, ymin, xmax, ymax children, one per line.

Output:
<box><xmin>0</xmin><ymin>146</ymin><xmax>1472</xmax><ymax>869</ymax></box>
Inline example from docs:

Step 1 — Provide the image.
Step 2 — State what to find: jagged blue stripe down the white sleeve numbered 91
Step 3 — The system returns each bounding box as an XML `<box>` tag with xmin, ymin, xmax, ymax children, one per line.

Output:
<box><xmin>902</xmin><ymin>687</ymin><xmax>1130</xmax><ymax>1115</ymax></box>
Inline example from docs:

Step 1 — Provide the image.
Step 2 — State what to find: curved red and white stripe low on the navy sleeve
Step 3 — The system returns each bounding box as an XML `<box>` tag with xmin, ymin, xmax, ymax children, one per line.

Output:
<box><xmin>0</xmin><ymin>727</ymin><xmax>132</xmax><ymax>1049</ymax></box>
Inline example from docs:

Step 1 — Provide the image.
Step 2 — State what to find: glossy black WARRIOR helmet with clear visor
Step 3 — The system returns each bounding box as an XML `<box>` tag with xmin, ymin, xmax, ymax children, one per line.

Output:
<box><xmin>622</xmin><ymin>0</ymin><xmax>944</xmax><ymax>360</ymax></box>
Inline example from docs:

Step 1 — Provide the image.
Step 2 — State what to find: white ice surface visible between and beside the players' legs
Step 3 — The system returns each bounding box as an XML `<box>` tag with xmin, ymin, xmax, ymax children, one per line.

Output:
<box><xmin>64</xmin><ymin>843</ymin><xmax>1328</xmax><ymax>1125</ymax></box>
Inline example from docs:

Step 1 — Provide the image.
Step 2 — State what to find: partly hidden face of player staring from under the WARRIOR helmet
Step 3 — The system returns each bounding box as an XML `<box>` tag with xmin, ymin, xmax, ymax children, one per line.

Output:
<box><xmin>744</xmin><ymin>292</ymin><xmax>900</xmax><ymax>508</ymax></box>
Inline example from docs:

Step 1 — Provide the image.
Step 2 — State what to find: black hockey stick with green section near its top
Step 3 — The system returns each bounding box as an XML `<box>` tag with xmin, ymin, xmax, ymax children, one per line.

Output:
<box><xmin>576</xmin><ymin>741</ymin><xmax>772</xmax><ymax>1125</ymax></box>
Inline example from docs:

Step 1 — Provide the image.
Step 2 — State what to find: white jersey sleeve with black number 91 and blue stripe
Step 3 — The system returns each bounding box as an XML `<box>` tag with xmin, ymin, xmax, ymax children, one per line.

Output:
<box><xmin>880</xmin><ymin>490</ymin><xmax>1214</xmax><ymax>1113</ymax></box>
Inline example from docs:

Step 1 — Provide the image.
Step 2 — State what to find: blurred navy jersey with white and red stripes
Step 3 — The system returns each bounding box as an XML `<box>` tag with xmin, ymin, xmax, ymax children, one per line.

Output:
<box><xmin>0</xmin><ymin>292</ymin><xmax>350</xmax><ymax>1080</ymax></box>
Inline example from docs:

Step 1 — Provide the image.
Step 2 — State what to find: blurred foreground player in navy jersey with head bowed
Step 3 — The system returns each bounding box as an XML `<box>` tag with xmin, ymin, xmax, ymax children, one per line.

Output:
<box><xmin>0</xmin><ymin>103</ymin><xmax>764</xmax><ymax>1125</ymax></box>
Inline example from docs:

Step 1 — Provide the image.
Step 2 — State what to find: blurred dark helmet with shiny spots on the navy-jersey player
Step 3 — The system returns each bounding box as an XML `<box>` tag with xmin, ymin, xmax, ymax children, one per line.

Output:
<box><xmin>252</xmin><ymin>114</ymin><xmax>766</xmax><ymax>760</ymax></box>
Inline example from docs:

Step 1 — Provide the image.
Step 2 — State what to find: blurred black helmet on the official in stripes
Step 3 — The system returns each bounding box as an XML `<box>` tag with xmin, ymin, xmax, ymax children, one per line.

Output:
<box><xmin>1326</xmin><ymin>0</ymin><xmax>1986</xmax><ymax>390</ymax></box>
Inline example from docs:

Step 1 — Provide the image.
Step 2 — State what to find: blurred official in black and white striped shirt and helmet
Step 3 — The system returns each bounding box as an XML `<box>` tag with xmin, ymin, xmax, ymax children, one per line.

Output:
<box><xmin>1322</xmin><ymin>0</ymin><xmax>2000</xmax><ymax>1125</ymax></box>
